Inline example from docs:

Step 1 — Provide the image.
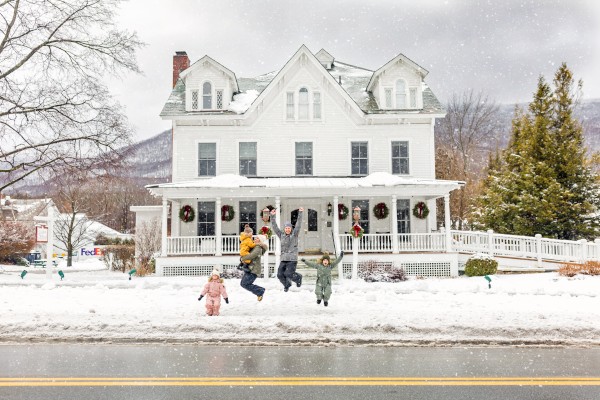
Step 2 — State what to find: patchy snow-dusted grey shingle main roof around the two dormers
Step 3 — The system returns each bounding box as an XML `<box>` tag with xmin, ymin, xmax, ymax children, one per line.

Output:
<box><xmin>160</xmin><ymin>49</ymin><xmax>443</xmax><ymax>117</ymax></box>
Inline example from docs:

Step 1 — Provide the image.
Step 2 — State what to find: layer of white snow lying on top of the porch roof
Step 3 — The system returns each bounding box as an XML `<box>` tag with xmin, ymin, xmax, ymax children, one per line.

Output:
<box><xmin>146</xmin><ymin>172</ymin><xmax>464</xmax><ymax>196</ymax></box>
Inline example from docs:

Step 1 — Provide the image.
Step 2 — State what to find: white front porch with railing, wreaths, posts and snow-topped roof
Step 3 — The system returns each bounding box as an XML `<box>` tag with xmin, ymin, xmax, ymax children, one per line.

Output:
<box><xmin>143</xmin><ymin>173</ymin><xmax>462</xmax><ymax>276</ymax></box>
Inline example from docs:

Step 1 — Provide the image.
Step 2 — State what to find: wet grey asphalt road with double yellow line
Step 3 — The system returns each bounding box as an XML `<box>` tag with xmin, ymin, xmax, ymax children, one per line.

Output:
<box><xmin>0</xmin><ymin>344</ymin><xmax>600</xmax><ymax>400</ymax></box>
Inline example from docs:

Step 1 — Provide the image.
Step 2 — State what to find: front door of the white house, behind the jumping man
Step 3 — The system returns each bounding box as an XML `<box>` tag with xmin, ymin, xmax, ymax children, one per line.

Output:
<box><xmin>283</xmin><ymin>201</ymin><xmax>322</xmax><ymax>253</ymax></box>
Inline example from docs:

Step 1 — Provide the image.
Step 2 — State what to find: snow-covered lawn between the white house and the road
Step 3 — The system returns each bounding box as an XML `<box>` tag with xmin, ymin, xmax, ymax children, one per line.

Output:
<box><xmin>0</xmin><ymin>263</ymin><xmax>600</xmax><ymax>345</ymax></box>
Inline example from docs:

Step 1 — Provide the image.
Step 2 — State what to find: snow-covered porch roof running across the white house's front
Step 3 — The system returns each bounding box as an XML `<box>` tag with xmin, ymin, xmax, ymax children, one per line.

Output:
<box><xmin>146</xmin><ymin>172</ymin><xmax>464</xmax><ymax>197</ymax></box>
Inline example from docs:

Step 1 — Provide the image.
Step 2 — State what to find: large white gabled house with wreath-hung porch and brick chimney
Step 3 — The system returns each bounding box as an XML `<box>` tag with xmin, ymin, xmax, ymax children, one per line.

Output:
<box><xmin>139</xmin><ymin>46</ymin><xmax>463</xmax><ymax>275</ymax></box>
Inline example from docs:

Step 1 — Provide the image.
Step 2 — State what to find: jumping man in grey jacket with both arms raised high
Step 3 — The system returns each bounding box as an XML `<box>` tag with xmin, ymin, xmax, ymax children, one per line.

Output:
<box><xmin>271</xmin><ymin>207</ymin><xmax>304</xmax><ymax>292</ymax></box>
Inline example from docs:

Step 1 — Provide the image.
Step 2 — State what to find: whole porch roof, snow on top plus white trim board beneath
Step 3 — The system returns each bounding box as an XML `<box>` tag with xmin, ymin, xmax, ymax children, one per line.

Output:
<box><xmin>146</xmin><ymin>172</ymin><xmax>465</xmax><ymax>199</ymax></box>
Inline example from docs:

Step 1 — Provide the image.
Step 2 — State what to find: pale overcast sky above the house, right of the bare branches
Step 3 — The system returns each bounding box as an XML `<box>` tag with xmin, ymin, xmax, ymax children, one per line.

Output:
<box><xmin>110</xmin><ymin>0</ymin><xmax>600</xmax><ymax>140</ymax></box>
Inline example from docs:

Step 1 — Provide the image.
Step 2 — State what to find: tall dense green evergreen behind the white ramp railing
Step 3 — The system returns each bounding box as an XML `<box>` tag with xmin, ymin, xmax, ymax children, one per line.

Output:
<box><xmin>474</xmin><ymin>64</ymin><xmax>600</xmax><ymax>240</ymax></box>
